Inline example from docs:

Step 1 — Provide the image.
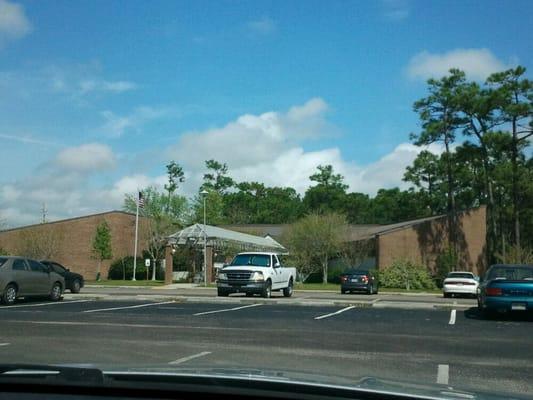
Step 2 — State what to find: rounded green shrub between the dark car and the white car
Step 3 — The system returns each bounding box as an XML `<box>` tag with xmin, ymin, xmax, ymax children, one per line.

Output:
<box><xmin>379</xmin><ymin>260</ymin><xmax>435</xmax><ymax>290</ymax></box>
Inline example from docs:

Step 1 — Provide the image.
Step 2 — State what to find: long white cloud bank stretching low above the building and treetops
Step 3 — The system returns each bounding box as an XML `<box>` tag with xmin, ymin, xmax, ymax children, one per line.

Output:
<box><xmin>0</xmin><ymin>98</ymin><xmax>441</xmax><ymax>226</ymax></box>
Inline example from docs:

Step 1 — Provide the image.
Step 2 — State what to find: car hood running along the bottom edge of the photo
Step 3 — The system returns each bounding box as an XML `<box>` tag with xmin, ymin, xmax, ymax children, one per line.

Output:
<box><xmin>0</xmin><ymin>364</ymin><xmax>531</xmax><ymax>400</ymax></box>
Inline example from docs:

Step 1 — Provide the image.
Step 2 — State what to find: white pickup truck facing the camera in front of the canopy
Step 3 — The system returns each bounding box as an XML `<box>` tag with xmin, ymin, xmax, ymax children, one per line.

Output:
<box><xmin>217</xmin><ymin>252</ymin><xmax>296</xmax><ymax>297</ymax></box>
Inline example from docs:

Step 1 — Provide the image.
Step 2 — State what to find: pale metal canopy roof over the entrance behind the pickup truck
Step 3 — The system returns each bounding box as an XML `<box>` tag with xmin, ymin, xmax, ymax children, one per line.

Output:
<box><xmin>168</xmin><ymin>224</ymin><xmax>287</xmax><ymax>253</ymax></box>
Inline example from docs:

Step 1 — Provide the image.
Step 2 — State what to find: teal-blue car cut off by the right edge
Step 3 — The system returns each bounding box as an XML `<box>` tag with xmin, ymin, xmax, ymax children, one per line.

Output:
<box><xmin>478</xmin><ymin>264</ymin><xmax>533</xmax><ymax>316</ymax></box>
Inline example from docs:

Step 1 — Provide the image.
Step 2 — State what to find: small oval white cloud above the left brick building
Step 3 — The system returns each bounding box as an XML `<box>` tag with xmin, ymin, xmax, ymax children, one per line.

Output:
<box><xmin>55</xmin><ymin>143</ymin><xmax>116</xmax><ymax>173</ymax></box>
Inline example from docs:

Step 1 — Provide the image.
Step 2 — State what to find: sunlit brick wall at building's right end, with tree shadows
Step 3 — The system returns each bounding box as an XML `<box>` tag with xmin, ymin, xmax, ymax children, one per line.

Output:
<box><xmin>377</xmin><ymin>206</ymin><xmax>486</xmax><ymax>273</ymax></box>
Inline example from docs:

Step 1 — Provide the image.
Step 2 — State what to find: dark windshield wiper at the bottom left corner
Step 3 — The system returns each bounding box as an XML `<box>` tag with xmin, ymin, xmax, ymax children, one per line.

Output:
<box><xmin>0</xmin><ymin>364</ymin><xmax>104</xmax><ymax>384</ymax></box>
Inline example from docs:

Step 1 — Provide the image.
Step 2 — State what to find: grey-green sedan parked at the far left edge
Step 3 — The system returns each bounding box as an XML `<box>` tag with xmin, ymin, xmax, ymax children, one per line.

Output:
<box><xmin>0</xmin><ymin>256</ymin><xmax>65</xmax><ymax>305</ymax></box>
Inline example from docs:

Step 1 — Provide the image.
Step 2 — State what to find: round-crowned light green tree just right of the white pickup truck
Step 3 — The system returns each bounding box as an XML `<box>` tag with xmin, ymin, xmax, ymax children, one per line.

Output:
<box><xmin>282</xmin><ymin>213</ymin><xmax>347</xmax><ymax>284</ymax></box>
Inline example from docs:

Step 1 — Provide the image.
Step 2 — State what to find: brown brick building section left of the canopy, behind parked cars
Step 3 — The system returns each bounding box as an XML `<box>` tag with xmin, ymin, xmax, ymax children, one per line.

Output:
<box><xmin>0</xmin><ymin>211</ymin><xmax>146</xmax><ymax>280</ymax></box>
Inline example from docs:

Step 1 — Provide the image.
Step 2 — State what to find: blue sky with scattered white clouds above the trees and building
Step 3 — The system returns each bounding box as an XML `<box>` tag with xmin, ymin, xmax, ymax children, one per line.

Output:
<box><xmin>0</xmin><ymin>0</ymin><xmax>533</xmax><ymax>225</ymax></box>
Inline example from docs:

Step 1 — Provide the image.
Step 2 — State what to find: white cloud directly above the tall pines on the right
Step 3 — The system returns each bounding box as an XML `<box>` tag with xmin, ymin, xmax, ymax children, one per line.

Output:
<box><xmin>406</xmin><ymin>49</ymin><xmax>510</xmax><ymax>80</ymax></box>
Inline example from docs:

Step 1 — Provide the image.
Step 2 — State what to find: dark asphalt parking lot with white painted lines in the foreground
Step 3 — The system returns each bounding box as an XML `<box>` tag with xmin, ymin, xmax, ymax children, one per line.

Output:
<box><xmin>0</xmin><ymin>298</ymin><xmax>533</xmax><ymax>393</ymax></box>
